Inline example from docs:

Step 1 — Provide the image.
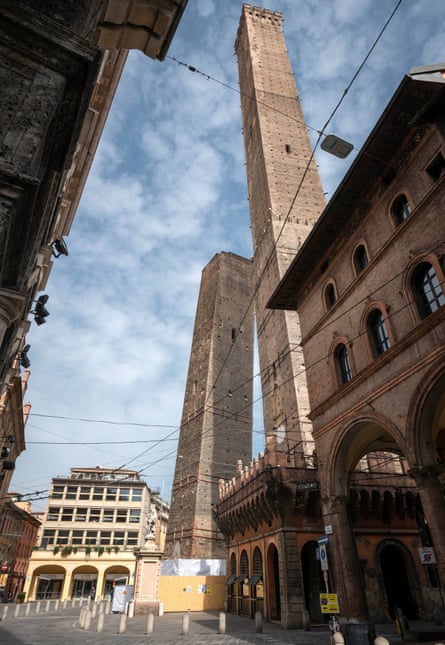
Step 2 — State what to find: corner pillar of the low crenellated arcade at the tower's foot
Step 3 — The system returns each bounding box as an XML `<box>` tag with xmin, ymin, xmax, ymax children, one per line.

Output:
<box><xmin>278</xmin><ymin>529</ymin><xmax>304</xmax><ymax>629</ymax></box>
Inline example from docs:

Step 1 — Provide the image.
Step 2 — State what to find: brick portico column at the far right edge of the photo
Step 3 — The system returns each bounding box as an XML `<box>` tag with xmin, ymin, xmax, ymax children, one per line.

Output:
<box><xmin>409</xmin><ymin>466</ymin><xmax>445</xmax><ymax>588</ymax></box>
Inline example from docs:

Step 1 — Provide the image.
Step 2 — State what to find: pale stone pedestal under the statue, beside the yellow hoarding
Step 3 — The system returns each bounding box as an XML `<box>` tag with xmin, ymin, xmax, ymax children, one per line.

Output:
<box><xmin>134</xmin><ymin>539</ymin><xmax>162</xmax><ymax>616</ymax></box>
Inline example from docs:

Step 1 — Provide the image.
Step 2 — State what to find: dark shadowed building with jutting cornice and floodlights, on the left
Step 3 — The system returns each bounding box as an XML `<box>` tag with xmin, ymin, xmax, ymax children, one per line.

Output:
<box><xmin>0</xmin><ymin>0</ymin><xmax>187</xmax><ymax>507</ymax></box>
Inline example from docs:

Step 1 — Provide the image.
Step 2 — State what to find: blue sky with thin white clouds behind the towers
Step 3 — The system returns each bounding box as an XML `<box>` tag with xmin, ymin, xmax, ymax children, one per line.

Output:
<box><xmin>10</xmin><ymin>0</ymin><xmax>445</xmax><ymax>511</ymax></box>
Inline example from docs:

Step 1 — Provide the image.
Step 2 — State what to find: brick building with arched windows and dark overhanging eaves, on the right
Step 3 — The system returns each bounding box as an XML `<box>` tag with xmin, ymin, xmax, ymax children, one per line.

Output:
<box><xmin>271</xmin><ymin>63</ymin><xmax>445</xmax><ymax>619</ymax></box>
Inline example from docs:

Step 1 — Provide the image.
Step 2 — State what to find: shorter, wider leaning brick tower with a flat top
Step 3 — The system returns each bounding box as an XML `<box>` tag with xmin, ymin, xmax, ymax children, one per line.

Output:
<box><xmin>165</xmin><ymin>253</ymin><xmax>253</xmax><ymax>559</ymax></box>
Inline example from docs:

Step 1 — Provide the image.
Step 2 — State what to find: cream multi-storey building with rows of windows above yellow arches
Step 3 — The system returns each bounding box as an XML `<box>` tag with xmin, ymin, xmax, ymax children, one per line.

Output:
<box><xmin>26</xmin><ymin>466</ymin><xmax>168</xmax><ymax>600</ymax></box>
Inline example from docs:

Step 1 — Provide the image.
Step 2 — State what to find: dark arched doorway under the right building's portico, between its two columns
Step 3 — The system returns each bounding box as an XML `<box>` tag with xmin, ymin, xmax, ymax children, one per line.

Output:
<box><xmin>380</xmin><ymin>544</ymin><xmax>418</xmax><ymax>620</ymax></box>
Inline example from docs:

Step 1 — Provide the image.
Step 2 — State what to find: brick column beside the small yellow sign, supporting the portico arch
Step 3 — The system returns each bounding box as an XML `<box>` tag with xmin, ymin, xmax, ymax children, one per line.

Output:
<box><xmin>323</xmin><ymin>497</ymin><xmax>368</xmax><ymax>621</ymax></box>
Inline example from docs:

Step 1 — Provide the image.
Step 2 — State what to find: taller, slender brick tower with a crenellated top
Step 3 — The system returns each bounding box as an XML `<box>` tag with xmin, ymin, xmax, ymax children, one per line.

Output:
<box><xmin>235</xmin><ymin>4</ymin><xmax>325</xmax><ymax>466</ymax></box>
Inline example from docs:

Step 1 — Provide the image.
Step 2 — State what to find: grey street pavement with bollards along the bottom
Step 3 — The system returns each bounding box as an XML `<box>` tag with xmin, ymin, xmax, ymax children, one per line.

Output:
<box><xmin>0</xmin><ymin>605</ymin><xmax>434</xmax><ymax>645</ymax></box>
